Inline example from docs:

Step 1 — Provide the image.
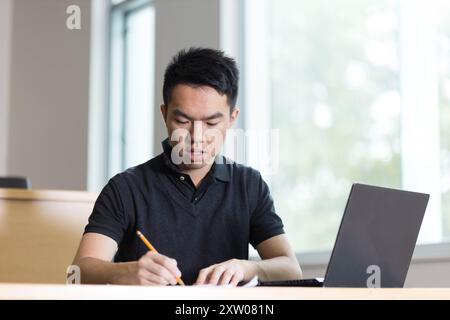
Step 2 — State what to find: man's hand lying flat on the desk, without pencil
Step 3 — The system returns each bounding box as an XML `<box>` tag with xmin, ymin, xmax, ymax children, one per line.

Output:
<box><xmin>195</xmin><ymin>259</ymin><xmax>252</xmax><ymax>287</ymax></box>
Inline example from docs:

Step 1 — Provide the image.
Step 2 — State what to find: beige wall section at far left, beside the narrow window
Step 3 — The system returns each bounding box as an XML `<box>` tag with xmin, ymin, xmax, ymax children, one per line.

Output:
<box><xmin>7</xmin><ymin>0</ymin><xmax>90</xmax><ymax>190</ymax></box>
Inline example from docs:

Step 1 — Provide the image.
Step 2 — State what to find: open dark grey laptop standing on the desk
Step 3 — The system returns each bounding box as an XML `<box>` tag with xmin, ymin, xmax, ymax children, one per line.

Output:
<box><xmin>258</xmin><ymin>183</ymin><xmax>430</xmax><ymax>288</ymax></box>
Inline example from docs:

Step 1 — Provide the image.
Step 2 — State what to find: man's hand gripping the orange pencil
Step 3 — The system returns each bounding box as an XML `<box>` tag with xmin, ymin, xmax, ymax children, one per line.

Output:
<box><xmin>114</xmin><ymin>251</ymin><xmax>181</xmax><ymax>286</ymax></box>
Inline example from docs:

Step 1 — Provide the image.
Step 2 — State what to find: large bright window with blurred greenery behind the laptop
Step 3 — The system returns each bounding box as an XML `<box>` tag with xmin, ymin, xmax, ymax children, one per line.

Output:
<box><xmin>244</xmin><ymin>0</ymin><xmax>450</xmax><ymax>252</ymax></box>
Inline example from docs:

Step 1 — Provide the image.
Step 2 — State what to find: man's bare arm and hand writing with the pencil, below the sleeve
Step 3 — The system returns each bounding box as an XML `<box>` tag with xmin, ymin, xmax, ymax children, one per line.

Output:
<box><xmin>73</xmin><ymin>233</ymin><xmax>181</xmax><ymax>285</ymax></box>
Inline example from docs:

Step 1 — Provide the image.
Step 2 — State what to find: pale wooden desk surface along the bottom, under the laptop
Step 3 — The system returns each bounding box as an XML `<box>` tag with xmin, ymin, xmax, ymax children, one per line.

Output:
<box><xmin>0</xmin><ymin>284</ymin><xmax>450</xmax><ymax>300</ymax></box>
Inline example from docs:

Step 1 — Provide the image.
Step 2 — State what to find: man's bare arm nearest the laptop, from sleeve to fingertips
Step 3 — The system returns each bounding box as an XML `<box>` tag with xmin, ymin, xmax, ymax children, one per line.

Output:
<box><xmin>196</xmin><ymin>234</ymin><xmax>302</xmax><ymax>286</ymax></box>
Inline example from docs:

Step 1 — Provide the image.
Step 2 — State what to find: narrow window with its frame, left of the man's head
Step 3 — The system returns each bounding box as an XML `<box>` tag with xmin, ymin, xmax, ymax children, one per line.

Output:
<box><xmin>108</xmin><ymin>0</ymin><xmax>155</xmax><ymax>176</ymax></box>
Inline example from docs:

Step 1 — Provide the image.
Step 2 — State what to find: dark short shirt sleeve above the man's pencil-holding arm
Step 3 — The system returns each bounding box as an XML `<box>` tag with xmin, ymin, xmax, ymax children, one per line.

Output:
<box><xmin>84</xmin><ymin>178</ymin><xmax>127</xmax><ymax>244</ymax></box>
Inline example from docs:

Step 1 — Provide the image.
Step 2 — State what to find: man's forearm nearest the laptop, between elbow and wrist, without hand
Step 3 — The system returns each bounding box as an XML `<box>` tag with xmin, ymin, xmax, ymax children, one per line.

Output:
<box><xmin>242</xmin><ymin>256</ymin><xmax>302</xmax><ymax>281</ymax></box>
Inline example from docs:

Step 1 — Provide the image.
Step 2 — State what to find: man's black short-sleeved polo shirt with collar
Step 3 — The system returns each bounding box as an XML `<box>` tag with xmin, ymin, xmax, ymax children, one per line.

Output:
<box><xmin>85</xmin><ymin>139</ymin><xmax>284</xmax><ymax>284</ymax></box>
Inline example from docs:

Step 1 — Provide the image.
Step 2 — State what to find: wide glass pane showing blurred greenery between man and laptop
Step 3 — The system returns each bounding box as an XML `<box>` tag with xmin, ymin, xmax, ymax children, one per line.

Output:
<box><xmin>268</xmin><ymin>0</ymin><xmax>402</xmax><ymax>252</ymax></box>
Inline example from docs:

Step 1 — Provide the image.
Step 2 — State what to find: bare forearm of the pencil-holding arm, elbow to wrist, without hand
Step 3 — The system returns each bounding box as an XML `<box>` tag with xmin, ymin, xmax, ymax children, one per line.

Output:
<box><xmin>74</xmin><ymin>257</ymin><xmax>135</xmax><ymax>284</ymax></box>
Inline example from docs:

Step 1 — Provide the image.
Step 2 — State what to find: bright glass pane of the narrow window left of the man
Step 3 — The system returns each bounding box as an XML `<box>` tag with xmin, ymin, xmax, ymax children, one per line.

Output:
<box><xmin>123</xmin><ymin>6</ymin><xmax>154</xmax><ymax>168</ymax></box>
